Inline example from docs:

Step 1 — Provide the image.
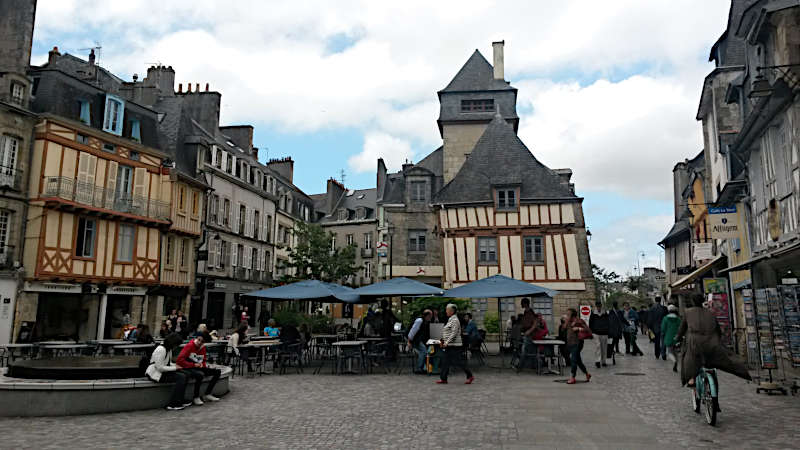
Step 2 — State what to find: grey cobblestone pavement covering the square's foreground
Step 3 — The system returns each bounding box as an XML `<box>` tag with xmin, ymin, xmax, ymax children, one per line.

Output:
<box><xmin>0</xmin><ymin>340</ymin><xmax>800</xmax><ymax>449</ymax></box>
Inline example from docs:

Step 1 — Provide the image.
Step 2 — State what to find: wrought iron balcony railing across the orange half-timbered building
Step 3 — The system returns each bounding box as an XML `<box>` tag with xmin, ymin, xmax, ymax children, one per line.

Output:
<box><xmin>42</xmin><ymin>177</ymin><xmax>170</xmax><ymax>221</ymax></box>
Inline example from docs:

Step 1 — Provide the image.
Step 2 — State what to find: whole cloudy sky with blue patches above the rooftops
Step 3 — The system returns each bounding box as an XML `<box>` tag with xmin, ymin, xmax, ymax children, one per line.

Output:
<box><xmin>32</xmin><ymin>0</ymin><xmax>730</xmax><ymax>273</ymax></box>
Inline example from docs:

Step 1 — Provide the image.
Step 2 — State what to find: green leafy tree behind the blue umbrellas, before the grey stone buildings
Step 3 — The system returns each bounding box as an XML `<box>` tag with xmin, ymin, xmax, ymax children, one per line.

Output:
<box><xmin>284</xmin><ymin>222</ymin><xmax>360</xmax><ymax>282</ymax></box>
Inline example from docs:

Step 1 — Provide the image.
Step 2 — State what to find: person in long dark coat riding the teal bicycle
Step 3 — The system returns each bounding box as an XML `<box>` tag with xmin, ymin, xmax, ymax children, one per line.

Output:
<box><xmin>676</xmin><ymin>294</ymin><xmax>752</xmax><ymax>386</ymax></box>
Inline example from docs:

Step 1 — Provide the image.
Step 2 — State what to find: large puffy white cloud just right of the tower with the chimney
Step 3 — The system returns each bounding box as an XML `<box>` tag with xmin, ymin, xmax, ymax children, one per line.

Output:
<box><xmin>519</xmin><ymin>75</ymin><xmax>702</xmax><ymax>200</ymax></box>
